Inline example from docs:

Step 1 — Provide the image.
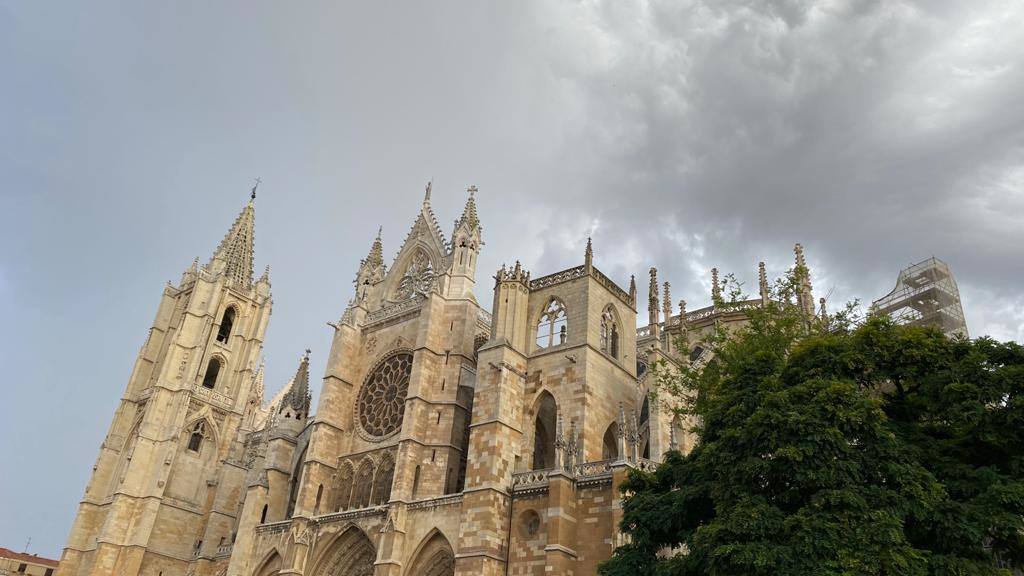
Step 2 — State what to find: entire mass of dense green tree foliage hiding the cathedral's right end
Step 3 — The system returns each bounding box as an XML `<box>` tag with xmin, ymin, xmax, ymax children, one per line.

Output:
<box><xmin>601</xmin><ymin>272</ymin><xmax>1024</xmax><ymax>576</ymax></box>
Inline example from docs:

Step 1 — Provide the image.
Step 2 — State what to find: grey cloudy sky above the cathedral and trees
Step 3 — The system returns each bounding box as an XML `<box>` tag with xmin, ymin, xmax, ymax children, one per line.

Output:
<box><xmin>0</xmin><ymin>0</ymin><xmax>1024</xmax><ymax>558</ymax></box>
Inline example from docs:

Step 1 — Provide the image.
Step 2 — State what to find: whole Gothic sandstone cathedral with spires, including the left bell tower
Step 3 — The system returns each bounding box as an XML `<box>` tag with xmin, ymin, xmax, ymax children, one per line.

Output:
<box><xmin>57</xmin><ymin>186</ymin><xmax>823</xmax><ymax>576</ymax></box>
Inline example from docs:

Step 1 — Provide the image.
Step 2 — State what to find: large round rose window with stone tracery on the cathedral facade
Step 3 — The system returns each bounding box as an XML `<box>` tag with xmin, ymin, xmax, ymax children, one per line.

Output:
<box><xmin>357</xmin><ymin>353</ymin><xmax>413</xmax><ymax>437</ymax></box>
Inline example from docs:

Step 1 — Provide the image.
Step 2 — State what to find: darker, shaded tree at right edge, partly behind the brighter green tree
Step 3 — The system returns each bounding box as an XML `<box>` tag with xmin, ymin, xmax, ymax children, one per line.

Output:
<box><xmin>783</xmin><ymin>319</ymin><xmax>1024</xmax><ymax>575</ymax></box>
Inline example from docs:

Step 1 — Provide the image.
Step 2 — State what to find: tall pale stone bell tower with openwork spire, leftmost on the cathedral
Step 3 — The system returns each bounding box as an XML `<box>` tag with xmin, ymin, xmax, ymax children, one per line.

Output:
<box><xmin>58</xmin><ymin>188</ymin><xmax>272</xmax><ymax>576</ymax></box>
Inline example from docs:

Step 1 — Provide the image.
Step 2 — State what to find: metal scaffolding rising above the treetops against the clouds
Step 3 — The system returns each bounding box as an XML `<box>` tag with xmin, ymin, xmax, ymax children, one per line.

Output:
<box><xmin>870</xmin><ymin>256</ymin><xmax>968</xmax><ymax>338</ymax></box>
